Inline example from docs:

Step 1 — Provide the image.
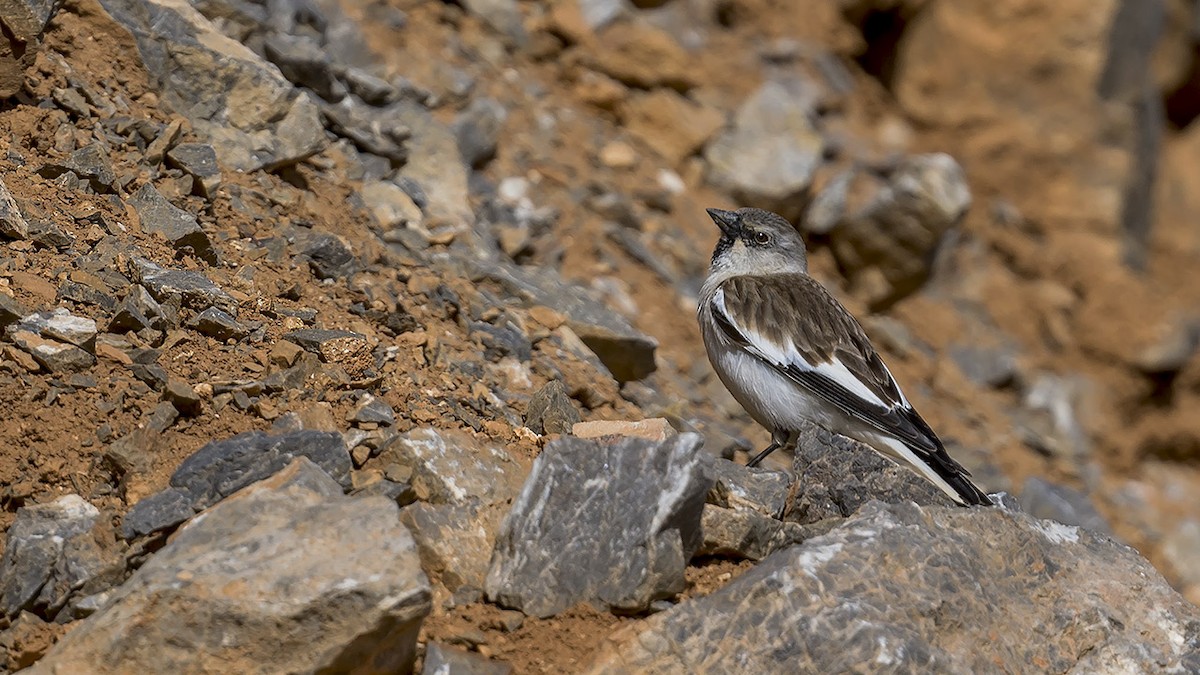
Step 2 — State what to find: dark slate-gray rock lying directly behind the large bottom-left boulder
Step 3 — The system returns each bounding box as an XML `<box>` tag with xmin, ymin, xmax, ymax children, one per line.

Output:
<box><xmin>121</xmin><ymin>430</ymin><xmax>350</xmax><ymax>539</ymax></box>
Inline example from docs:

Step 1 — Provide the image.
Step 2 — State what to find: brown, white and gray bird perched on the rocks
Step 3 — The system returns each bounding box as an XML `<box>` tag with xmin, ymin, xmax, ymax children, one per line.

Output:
<box><xmin>696</xmin><ymin>208</ymin><xmax>992</xmax><ymax>506</ymax></box>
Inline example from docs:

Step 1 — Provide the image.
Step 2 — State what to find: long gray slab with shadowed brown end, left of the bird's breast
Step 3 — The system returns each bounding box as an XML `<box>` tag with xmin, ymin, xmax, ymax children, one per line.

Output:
<box><xmin>470</xmin><ymin>261</ymin><xmax>659</xmax><ymax>382</ymax></box>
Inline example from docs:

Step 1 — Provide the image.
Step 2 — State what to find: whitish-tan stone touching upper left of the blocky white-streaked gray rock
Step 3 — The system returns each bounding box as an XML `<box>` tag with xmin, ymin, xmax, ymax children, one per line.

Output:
<box><xmin>383</xmin><ymin>429</ymin><xmax>524</xmax><ymax>504</ymax></box>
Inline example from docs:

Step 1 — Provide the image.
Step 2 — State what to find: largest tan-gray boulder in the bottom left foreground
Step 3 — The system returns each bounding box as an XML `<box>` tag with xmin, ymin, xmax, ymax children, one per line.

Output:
<box><xmin>30</xmin><ymin>459</ymin><xmax>431</xmax><ymax>675</ymax></box>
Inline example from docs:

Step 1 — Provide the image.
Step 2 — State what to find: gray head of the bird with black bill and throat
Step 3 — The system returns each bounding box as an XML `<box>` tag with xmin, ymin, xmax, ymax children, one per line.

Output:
<box><xmin>706</xmin><ymin>208</ymin><xmax>809</xmax><ymax>275</ymax></box>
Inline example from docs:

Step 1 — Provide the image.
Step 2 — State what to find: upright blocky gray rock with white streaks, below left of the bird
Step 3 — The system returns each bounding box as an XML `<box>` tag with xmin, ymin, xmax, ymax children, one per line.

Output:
<box><xmin>485</xmin><ymin>434</ymin><xmax>709</xmax><ymax>617</ymax></box>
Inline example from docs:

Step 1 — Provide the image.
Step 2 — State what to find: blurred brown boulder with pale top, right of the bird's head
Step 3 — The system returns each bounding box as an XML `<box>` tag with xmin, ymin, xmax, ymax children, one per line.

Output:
<box><xmin>830</xmin><ymin>154</ymin><xmax>971</xmax><ymax>306</ymax></box>
